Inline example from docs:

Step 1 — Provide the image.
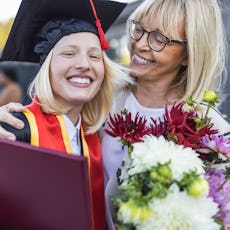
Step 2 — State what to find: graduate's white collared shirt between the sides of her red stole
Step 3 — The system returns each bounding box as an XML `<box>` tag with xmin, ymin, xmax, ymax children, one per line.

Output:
<box><xmin>63</xmin><ymin>114</ymin><xmax>82</xmax><ymax>155</ymax></box>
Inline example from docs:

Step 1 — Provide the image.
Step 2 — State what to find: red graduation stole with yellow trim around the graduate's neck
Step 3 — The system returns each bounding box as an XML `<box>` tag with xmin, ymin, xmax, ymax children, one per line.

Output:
<box><xmin>23</xmin><ymin>102</ymin><xmax>106</xmax><ymax>230</ymax></box>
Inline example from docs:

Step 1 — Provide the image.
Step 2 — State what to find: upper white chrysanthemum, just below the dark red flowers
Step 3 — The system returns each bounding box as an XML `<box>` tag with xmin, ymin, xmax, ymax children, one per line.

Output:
<box><xmin>128</xmin><ymin>135</ymin><xmax>204</xmax><ymax>180</ymax></box>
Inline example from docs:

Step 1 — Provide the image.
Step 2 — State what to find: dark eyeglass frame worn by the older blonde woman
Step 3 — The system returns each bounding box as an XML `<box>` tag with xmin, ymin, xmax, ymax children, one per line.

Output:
<box><xmin>129</xmin><ymin>19</ymin><xmax>187</xmax><ymax>52</ymax></box>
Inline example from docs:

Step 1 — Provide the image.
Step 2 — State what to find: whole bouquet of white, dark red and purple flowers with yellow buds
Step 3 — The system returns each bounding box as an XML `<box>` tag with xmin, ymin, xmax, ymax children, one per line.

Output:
<box><xmin>106</xmin><ymin>91</ymin><xmax>230</xmax><ymax>230</ymax></box>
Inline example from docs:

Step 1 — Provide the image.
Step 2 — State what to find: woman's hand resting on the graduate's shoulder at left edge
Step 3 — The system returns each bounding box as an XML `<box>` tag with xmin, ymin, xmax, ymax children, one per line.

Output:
<box><xmin>0</xmin><ymin>102</ymin><xmax>25</xmax><ymax>140</ymax></box>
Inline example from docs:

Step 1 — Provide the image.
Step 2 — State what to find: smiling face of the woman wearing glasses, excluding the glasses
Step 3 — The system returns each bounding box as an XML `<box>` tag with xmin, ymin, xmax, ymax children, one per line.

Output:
<box><xmin>130</xmin><ymin>15</ymin><xmax>187</xmax><ymax>85</ymax></box>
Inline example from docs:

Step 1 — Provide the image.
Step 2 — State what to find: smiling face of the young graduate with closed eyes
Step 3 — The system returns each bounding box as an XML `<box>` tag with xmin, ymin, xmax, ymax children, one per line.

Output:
<box><xmin>50</xmin><ymin>32</ymin><xmax>105</xmax><ymax>112</ymax></box>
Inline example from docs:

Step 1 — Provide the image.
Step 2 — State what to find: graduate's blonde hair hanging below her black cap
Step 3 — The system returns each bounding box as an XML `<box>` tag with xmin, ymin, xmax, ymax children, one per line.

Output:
<box><xmin>29</xmin><ymin>50</ymin><xmax>132</xmax><ymax>134</ymax></box>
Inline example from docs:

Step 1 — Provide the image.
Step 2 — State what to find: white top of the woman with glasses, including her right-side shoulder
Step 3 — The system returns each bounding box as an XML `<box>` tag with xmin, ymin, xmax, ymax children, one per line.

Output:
<box><xmin>102</xmin><ymin>92</ymin><xmax>230</xmax><ymax>185</ymax></box>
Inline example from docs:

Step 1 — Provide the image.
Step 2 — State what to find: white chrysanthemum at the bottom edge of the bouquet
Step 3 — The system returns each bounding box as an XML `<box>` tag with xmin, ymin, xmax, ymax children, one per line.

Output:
<box><xmin>136</xmin><ymin>185</ymin><xmax>220</xmax><ymax>230</ymax></box>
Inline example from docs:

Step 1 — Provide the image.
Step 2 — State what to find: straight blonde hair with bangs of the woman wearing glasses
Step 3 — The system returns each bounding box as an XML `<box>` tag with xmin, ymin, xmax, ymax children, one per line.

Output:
<box><xmin>130</xmin><ymin>0</ymin><xmax>226</xmax><ymax>101</ymax></box>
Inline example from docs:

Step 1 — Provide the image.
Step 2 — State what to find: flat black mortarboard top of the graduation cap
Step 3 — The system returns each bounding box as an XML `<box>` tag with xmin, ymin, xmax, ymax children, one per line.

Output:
<box><xmin>1</xmin><ymin>0</ymin><xmax>126</xmax><ymax>63</ymax></box>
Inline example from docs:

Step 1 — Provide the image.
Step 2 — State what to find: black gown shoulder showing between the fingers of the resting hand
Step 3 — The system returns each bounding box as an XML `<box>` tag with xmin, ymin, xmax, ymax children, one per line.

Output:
<box><xmin>1</xmin><ymin>113</ymin><xmax>31</xmax><ymax>143</ymax></box>
